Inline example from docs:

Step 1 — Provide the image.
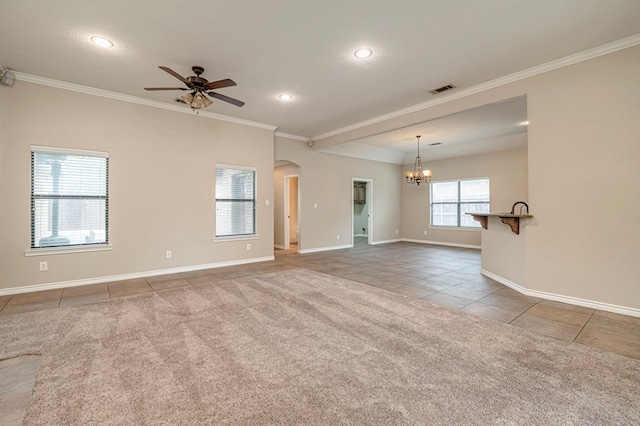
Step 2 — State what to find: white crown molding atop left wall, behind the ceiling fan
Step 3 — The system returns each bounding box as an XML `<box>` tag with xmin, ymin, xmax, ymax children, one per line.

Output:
<box><xmin>13</xmin><ymin>71</ymin><xmax>278</xmax><ymax>131</ymax></box>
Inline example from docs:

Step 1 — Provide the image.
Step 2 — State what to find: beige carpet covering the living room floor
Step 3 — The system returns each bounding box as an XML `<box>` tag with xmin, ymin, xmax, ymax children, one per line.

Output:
<box><xmin>0</xmin><ymin>269</ymin><xmax>640</xmax><ymax>425</ymax></box>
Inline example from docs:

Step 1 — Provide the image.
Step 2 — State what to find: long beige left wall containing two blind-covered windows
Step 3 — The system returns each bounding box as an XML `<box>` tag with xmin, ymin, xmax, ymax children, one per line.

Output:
<box><xmin>0</xmin><ymin>82</ymin><xmax>273</xmax><ymax>289</ymax></box>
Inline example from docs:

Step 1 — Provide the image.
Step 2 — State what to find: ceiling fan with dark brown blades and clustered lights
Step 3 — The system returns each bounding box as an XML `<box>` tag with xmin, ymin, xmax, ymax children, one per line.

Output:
<box><xmin>144</xmin><ymin>66</ymin><xmax>244</xmax><ymax>109</ymax></box>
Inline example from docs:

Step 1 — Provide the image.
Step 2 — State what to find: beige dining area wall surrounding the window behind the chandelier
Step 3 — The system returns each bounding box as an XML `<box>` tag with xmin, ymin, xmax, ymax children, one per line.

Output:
<box><xmin>402</xmin><ymin>146</ymin><xmax>527</xmax><ymax>246</ymax></box>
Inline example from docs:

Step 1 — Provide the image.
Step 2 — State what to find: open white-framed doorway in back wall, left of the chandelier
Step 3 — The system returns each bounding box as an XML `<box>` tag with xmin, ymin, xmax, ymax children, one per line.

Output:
<box><xmin>351</xmin><ymin>178</ymin><xmax>373</xmax><ymax>246</ymax></box>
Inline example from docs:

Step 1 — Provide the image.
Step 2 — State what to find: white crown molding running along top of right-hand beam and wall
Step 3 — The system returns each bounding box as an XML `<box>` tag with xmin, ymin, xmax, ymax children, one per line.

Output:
<box><xmin>311</xmin><ymin>34</ymin><xmax>640</xmax><ymax>141</ymax></box>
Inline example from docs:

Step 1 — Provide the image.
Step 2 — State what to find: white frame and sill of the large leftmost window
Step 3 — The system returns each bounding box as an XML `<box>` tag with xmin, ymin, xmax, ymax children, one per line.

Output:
<box><xmin>25</xmin><ymin>145</ymin><xmax>112</xmax><ymax>256</ymax></box>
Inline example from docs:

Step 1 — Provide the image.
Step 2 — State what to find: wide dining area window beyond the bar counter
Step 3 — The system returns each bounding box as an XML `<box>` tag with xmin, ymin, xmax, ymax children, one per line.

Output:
<box><xmin>431</xmin><ymin>179</ymin><xmax>489</xmax><ymax>228</ymax></box>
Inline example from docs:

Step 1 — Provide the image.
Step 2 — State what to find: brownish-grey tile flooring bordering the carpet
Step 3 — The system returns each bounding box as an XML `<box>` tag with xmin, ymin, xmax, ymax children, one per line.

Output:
<box><xmin>0</xmin><ymin>238</ymin><xmax>640</xmax><ymax>425</ymax></box>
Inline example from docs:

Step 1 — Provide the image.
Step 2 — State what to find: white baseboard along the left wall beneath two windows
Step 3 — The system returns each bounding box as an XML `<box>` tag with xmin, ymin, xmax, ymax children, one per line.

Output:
<box><xmin>0</xmin><ymin>256</ymin><xmax>275</xmax><ymax>296</ymax></box>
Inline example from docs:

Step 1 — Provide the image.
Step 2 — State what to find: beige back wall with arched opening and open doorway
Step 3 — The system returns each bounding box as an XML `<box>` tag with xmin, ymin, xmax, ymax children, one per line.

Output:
<box><xmin>275</xmin><ymin>137</ymin><xmax>402</xmax><ymax>252</ymax></box>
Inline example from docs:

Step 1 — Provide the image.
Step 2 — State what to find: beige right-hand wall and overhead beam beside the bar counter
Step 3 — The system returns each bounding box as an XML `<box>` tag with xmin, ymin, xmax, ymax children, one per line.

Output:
<box><xmin>316</xmin><ymin>46</ymin><xmax>640</xmax><ymax>315</ymax></box>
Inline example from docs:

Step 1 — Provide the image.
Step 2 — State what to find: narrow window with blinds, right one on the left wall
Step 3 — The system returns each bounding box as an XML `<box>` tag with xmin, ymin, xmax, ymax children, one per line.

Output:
<box><xmin>216</xmin><ymin>165</ymin><xmax>256</xmax><ymax>237</ymax></box>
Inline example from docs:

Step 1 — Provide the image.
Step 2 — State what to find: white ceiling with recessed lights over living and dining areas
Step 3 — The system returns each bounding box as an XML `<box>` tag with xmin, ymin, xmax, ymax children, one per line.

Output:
<box><xmin>0</xmin><ymin>0</ymin><xmax>640</xmax><ymax>162</ymax></box>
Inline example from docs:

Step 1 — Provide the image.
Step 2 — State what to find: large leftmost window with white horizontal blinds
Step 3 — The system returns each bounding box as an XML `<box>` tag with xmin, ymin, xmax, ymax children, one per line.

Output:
<box><xmin>31</xmin><ymin>146</ymin><xmax>109</xmax><ymax>248</ymax></box>
